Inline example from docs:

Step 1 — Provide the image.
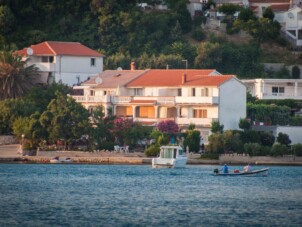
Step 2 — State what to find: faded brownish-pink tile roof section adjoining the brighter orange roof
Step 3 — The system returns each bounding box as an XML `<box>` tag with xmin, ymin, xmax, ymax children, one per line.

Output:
<box><xmin>82</xmin><ymin>70</ymin><xmax>148</xmax><ymax>88</ymax></box>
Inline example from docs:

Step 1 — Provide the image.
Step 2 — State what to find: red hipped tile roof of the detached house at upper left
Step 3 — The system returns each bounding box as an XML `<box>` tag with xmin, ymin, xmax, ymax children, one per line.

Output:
<box><xmin>17</xmin><ymin>41</ymin><xmax>103</xmax><ymax>57</ymax></box>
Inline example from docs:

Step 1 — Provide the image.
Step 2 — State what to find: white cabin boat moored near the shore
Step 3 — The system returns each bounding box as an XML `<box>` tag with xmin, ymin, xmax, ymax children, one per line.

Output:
<box><xmin>152</xmin><ymin>145</ymin><xmax>188</xmax><ymax>168</ymax></box>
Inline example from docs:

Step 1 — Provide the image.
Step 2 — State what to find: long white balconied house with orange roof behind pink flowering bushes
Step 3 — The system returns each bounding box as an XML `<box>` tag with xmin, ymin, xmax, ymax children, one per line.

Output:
<box><xmin>72</xmin><ymin>63</ymin><xmax>246</xmax><ymax>143</ymax></box>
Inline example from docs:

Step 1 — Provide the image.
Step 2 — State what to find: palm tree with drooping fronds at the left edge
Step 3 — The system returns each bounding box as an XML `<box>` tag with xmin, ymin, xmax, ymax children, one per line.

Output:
<box><xmin>0</xmin><ymin>50</ymin><xmax>39</xmax><ymax>100</ymax></box>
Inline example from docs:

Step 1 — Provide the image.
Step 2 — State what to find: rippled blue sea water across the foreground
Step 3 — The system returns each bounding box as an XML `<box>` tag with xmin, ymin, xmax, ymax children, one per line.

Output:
<box><xmin>0</xmin><ymin>164</ymin><xmax>302</xmax><ymax>226</ymax></box>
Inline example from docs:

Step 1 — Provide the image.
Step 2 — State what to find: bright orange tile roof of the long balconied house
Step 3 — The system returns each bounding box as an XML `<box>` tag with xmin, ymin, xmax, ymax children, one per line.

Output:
<box><xmin>127</xmin><ymin>69</ymin><xmax>234</xmax><ymax>87</ymax></box>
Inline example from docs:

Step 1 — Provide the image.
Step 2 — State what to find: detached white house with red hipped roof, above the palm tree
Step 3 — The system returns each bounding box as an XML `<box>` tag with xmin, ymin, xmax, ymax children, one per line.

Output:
<box><xmin>17</xmin><ymin>41</ymin><xmax>104</xmax><ymax>86</ymax></box>
